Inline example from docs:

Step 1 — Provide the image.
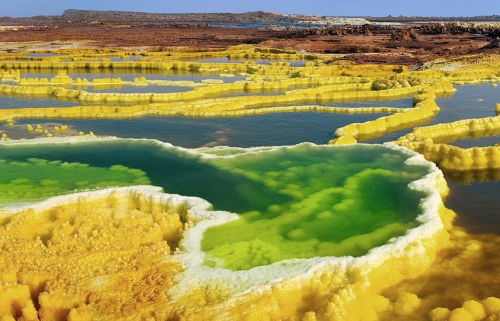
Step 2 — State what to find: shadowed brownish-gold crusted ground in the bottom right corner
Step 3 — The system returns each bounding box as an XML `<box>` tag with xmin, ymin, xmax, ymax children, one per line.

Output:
<box><xmin>379</xmin><ymin>222</ymin><xmax>500</xmax><ymax>321</ymax></box>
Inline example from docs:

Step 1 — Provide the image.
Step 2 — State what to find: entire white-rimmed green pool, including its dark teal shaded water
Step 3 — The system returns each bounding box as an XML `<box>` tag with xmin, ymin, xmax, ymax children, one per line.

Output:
<box><xmin>0</xmin><ymin>140</ymin><xmax>428</xmax><ymax>270</ymax></box>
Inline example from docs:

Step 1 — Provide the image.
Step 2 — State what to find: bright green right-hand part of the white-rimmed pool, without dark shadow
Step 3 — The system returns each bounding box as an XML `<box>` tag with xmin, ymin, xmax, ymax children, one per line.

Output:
<box><xmin>202</xmin><ymin>146</ymin><xmax>427</xmax><ymax>270</ymax></box>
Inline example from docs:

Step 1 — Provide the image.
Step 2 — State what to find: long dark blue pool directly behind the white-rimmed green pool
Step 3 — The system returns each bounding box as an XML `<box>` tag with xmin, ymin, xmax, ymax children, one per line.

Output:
<box><xmin>9</xmin><ymin>112</ymin><xmax>388</xmax><ymax>148</ymax></box>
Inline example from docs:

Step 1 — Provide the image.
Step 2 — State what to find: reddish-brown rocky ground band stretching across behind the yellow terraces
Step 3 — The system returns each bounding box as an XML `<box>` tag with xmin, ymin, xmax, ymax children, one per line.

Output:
<box><xmin>0</xmin><ymin>24</ymin><xmax>500</xmax><ymax>65</ymax></box>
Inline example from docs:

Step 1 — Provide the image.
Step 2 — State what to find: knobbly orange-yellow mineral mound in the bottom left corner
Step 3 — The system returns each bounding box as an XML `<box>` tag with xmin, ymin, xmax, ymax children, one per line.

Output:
<box><xmin>0</xmin><ymin>189</ymin><xmax>183</xmax><ymax>320</ymax></box>
